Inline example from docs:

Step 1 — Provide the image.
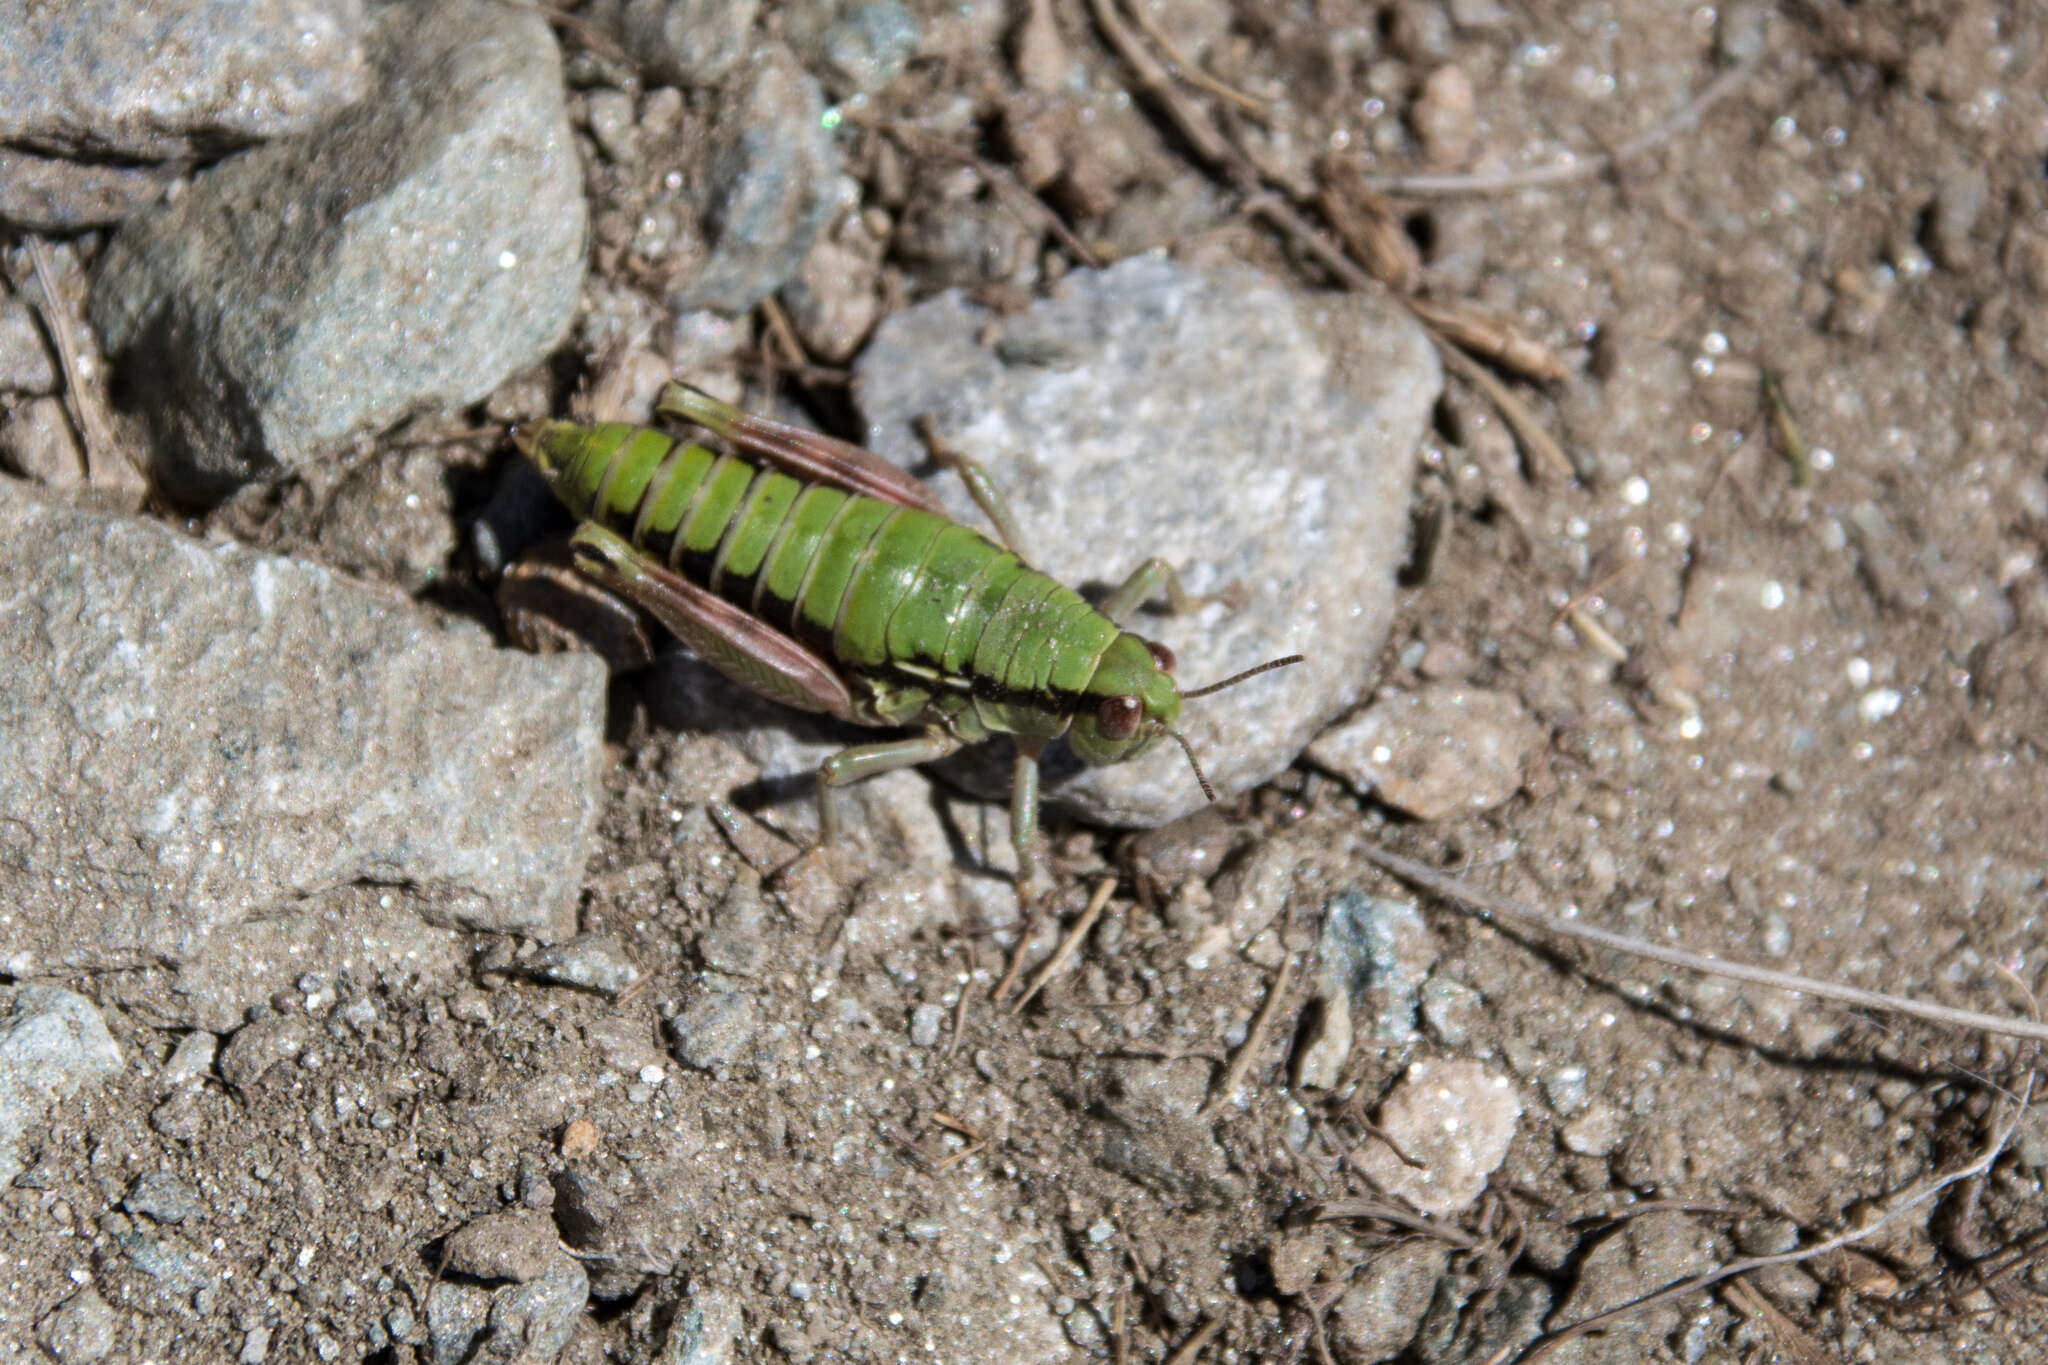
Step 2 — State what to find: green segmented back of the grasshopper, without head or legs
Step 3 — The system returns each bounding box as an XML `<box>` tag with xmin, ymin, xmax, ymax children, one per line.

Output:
<box><xmin>549</xmin><ymin>424</ymin><xmax>1116</xmax><ymax>703</ymax></box>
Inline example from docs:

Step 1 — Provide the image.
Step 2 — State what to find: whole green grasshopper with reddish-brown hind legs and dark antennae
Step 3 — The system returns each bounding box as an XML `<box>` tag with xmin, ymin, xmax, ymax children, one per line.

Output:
<box><xmin>512</xmin><ymin>385</ymin><xmax>1300</xmax><ymax>898</ymax></box>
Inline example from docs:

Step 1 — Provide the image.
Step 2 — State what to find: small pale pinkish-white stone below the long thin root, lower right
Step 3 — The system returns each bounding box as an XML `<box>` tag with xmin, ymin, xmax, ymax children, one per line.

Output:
<box><xmin>1358</xmin><ymin>1058</ymin><xmax>1522</xmax><ymax>1218</ymax></box>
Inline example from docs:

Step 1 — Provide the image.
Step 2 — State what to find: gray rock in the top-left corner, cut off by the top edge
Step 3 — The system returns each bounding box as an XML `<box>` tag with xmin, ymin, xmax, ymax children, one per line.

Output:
<box><xmin>0</xmin><ymin>0</ymin><xmax>369</xmax><ymax>162</ymax></box>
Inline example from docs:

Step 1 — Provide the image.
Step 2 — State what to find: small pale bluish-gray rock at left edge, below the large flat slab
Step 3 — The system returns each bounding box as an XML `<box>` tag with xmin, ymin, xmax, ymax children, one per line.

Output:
<box><xmin>0</xmin><ymin>986</ymin><xmax>121</xmax><ymax>1189</ymax></box>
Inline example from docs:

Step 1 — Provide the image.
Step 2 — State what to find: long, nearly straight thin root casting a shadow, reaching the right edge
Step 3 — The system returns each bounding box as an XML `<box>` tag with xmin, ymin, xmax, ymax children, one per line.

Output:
<box><xmin>1358</xmin><ymin>841</ymin><xmax>2048</xmax><ymax>1042</ymax></box>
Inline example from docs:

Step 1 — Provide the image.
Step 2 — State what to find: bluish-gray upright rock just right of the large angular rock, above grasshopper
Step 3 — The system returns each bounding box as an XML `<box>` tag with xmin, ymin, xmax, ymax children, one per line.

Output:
<box><xmin>668</xmin><ymin>45</ymin><xmax>840</xmax><ymax>315</ymax></box>
